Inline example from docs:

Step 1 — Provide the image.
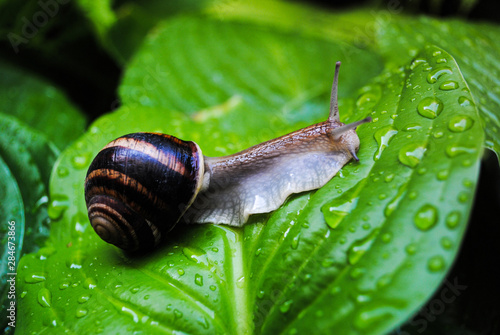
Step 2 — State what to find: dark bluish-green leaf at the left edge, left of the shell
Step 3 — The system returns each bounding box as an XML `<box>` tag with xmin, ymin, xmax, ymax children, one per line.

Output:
<box><xmin>0</xmin><ymin>114</ymin><xmax>58</xmax><ymax>329</ymax></box>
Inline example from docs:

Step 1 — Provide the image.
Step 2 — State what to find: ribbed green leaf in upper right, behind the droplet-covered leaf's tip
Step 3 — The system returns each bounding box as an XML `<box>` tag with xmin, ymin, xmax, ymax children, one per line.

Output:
<box><xmin>377</xmin><ymin>17</ymin><xmax>500</xmax><ymax>159</ymax></box>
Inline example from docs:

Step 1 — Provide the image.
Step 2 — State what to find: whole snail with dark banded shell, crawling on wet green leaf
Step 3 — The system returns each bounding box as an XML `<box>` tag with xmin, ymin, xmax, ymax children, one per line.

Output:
<box><xmin>85</xmin><ymin>62</ymin><xmax>371</xmax><ymax>251</ymax></box>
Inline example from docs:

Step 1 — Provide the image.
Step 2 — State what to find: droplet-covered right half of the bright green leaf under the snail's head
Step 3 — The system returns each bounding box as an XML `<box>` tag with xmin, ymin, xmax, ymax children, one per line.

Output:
<box><xmin>252</xmin><ymin>47</ymin><xmax>483</xmax><ymax>334</ymax></box>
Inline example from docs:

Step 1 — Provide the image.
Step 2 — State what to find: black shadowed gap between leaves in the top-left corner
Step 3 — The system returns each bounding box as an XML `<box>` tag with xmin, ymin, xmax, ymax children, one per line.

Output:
<box><xmin>0</xmin><ymin>0</ymin><xmax>120</xmax><ymax>118</ymax></box>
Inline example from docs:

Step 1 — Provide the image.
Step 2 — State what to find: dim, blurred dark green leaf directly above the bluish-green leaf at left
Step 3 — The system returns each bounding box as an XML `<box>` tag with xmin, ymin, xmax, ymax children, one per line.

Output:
<box><xmin>0</xmin><ymin>62</ymin><xmax>86</xmax><ymax>152</ymax></box>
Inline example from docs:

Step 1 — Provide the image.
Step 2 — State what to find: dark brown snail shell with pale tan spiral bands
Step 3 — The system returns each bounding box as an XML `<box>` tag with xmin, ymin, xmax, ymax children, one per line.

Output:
<box><xmin>85</xmin><ymin>133</ymin><xmax>204</xmax><ymax>251</ymax></box>
